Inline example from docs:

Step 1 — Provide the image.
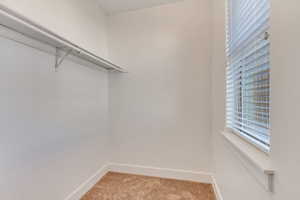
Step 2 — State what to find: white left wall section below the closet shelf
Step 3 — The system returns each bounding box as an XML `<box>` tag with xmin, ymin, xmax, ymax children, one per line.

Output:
<box><xmin>0</xmin><ymin>34</ymin><xmax>110</xmax><ymax>200</ymax></box>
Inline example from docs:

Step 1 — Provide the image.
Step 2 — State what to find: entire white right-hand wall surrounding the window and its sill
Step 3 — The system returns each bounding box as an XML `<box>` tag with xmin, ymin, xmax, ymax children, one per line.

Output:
<box><xmin>212</xmin><ymin>0</ymin><xmax>300</xmax><ymax>200</ymax></box>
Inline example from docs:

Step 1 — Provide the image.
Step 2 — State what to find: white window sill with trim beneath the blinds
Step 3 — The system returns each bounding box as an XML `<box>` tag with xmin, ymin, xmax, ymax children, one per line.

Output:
<box><xmin>222</xmin><ymin>131</ymin><xmax>275</xmax><ymax>192</ymax></box>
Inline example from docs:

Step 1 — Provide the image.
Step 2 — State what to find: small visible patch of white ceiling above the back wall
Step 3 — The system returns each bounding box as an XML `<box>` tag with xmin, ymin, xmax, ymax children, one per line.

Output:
<box><xmin>98</xmin><ymin>0</ymin><xmax>180</xmax><ymax>14</ymax></box>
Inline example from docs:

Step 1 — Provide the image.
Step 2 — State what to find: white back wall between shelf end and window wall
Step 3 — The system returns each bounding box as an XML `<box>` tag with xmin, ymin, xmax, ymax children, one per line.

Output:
<box><xmin>108</xmin><ymin>0</ymin><xmax>212</xmax><ymax>172</ymax></box>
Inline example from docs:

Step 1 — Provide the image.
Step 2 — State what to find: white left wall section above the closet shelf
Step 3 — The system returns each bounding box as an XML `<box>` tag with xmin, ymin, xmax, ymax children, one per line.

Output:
<box><xmin>0</xmin><ymin>0</ymin><xmax>107</xmax><ymax>58</ymax></box>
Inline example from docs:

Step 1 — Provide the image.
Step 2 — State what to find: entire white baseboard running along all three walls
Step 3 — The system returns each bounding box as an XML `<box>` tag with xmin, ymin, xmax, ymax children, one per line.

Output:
<box><xmin>65</xmin><ymin>163</ymin><xmax>223</xmax><ymax>200</ymax></box>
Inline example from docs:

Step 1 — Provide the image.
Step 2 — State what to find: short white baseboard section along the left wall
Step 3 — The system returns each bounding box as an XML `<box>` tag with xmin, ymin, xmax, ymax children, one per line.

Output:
<box><xmin>65</xmin><ymin>165</ymin><xmax>109</xmax><ymax>200</ymax></box>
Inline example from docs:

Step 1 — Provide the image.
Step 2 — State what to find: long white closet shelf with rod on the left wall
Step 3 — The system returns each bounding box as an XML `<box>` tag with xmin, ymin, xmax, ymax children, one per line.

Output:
<box><xmin>0</xmin><ymin>4</ymin><xmax>126</xmax><ymax>72</ymax></box>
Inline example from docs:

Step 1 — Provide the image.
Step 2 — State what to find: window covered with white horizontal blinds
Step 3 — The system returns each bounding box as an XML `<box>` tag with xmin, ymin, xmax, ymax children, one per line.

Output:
<box><xmin>226</xmin><ymin>0</ymin><xmax>270</xmax><ymax>151</ymax></box>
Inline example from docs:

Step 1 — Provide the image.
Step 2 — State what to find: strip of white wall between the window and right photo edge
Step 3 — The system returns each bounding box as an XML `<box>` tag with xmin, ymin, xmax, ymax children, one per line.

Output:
<box><xmin>271</xmin><ymin>0</ymin><xmax>300</xmax><ymax>200</ymax></box>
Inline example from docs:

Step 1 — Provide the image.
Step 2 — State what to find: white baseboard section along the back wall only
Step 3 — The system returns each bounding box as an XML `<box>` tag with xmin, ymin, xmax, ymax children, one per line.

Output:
<box><xmin>109</xmin><ymin>163</ymin><xmax>212</xmax><ymax>183</ymax></box>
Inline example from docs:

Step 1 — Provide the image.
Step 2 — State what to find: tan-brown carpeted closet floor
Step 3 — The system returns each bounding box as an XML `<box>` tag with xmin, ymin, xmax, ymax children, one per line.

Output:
<box><xmin>81</xmin><ymin>172</ymin><xmax>215</xmax><ymax>200</ymax></box>
